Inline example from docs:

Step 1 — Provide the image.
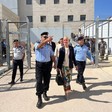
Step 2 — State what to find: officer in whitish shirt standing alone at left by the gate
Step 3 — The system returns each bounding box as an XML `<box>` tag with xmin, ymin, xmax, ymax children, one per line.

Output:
<box><xmin>9</xmin><ymin>40</ymin><xmax>25</xmax><ymax>85</ymax></box>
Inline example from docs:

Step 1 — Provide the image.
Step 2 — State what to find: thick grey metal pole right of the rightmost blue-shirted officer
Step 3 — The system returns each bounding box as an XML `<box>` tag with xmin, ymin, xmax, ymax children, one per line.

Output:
<box><xmin>95</xmin><ymin>18</ymin><xmax>99</xmax><ymax>67</ymax></box>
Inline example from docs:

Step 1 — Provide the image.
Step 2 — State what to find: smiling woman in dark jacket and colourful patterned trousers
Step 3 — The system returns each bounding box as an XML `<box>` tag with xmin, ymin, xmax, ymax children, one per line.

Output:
<box><xmin>57</xmin><ymin>37</ymin><xmax>76</xmax><ymax>99</ymax></box>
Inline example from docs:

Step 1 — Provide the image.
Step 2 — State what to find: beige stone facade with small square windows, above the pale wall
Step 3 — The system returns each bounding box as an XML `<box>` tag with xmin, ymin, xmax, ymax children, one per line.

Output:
<box><xmin>33</xmin><ymin>0</ymin><xmax>94</xmax><ymax>32</ymax></box>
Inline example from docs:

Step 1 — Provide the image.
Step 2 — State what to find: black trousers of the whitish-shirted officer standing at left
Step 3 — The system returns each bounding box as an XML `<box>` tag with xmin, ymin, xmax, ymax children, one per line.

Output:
<box><xmin>12</xmin><ymin>59</ymin><xmax>23</xmax><ymax>82</ymax></box>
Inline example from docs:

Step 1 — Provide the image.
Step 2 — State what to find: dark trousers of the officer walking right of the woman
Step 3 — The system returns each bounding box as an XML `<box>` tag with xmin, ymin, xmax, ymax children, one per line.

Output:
<box><xmin>76</xmin><ymin>61</ymin><xmax>86</xmax><ymax>84</ymax></box>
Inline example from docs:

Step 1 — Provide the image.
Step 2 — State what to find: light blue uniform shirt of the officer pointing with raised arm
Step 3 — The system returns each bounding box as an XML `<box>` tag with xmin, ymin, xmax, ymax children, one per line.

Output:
<box><xmin>34</xmin><ymin>42</ymin><xmax>54</xmax><ymax>62</ymax></box>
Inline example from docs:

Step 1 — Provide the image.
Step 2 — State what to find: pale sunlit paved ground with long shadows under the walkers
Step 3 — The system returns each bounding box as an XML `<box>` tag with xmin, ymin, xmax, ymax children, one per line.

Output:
<box><xmin>0</xmin><ymin>55</ymin><xmax>112</xmax><ymax>112</ymax></box>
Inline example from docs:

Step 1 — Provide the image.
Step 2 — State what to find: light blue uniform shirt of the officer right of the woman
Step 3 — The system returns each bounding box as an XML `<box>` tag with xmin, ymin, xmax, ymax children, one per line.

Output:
<box><xmin>74</xmin><ymin>44</ymin><xmax>93</xmax><ymax>61</ymax></box>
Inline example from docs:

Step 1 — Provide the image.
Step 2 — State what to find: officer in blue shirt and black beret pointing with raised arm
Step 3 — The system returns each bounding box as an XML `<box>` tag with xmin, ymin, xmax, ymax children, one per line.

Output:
<box><xmin>34</xmin><ymin>32</ymin><xmax>55</xmax><ymax>108</ymax></box>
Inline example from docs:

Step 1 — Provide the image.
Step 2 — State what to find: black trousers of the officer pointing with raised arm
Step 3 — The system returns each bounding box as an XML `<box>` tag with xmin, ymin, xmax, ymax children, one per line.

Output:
<box><xmin>35</xmin><ymin>61</ymin><xmax>51</xmax><ymax>95</ymax></box>
